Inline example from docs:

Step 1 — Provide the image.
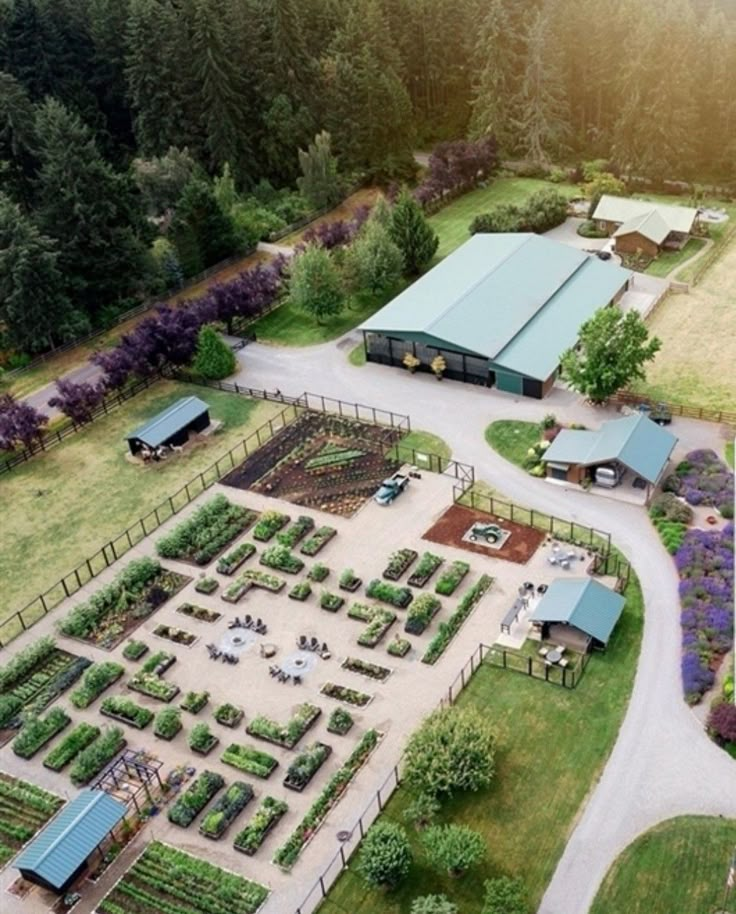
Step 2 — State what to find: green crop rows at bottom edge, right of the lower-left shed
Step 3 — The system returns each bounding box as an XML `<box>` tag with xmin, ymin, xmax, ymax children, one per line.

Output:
<box><xmin>97</xmin><ymin>841</ymin><xmax>268</xmax><ymax>914</ymax></box>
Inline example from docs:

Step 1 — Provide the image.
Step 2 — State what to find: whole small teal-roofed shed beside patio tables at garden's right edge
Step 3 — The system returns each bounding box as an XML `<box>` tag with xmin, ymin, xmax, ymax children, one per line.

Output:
<box><xmin>530</xmin><ymin>578</ymin><xmax>626</xmax><ymax>650</ymax></box>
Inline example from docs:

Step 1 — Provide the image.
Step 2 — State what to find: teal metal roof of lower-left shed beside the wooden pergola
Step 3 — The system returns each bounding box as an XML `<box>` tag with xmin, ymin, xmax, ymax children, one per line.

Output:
<box><xmin>15</xmin><ymin>790</ymin><xmax>125</xmax><ymax>889</ymax></box>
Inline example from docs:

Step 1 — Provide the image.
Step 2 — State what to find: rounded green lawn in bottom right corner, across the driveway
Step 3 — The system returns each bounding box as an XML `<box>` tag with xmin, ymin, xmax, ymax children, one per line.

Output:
<box><xmin>590</xmin><ymin>816</ymin><xmax>736</xmax><ymax>914</ymax></box>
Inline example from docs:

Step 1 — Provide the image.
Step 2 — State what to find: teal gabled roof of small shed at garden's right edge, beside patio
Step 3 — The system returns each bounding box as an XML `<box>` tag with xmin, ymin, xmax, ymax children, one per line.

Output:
<box><xmin>530</xmin><ymin>578</ymin><xmax>626</xmax><ymax>644</ymax></box>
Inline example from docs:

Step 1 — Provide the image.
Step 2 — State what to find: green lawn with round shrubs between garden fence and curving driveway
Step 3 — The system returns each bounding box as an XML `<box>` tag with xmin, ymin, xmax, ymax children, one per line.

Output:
<box><xmin>320</xmin><ymin>582</ymin><xmax>640</xmax><ymax>914</ymax></box>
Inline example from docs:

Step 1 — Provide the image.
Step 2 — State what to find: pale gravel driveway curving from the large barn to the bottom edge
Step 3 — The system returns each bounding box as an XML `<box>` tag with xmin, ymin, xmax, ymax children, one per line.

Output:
<box><xmin>231</xmin><ymin>336</ymin><xmax>736</xmax><ymax>914</ymax></box>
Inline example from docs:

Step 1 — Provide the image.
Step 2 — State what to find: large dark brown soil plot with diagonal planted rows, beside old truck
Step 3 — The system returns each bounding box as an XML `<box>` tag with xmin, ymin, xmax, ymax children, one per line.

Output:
<box><xmin>222</xmin><ymin>413</ymin><xmax>402</xmax><ymax>517</ymax></box>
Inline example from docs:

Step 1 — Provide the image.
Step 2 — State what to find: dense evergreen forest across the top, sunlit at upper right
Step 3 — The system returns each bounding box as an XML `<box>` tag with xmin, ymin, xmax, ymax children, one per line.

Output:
<box><xmin>0</xmin><ymin>0</ymin><xmax>736</xmax><ymax>352</ymax></box>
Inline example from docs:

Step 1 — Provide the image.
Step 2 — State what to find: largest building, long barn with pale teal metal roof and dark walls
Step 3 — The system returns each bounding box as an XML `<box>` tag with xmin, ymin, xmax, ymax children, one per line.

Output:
<box><xmin>361</xmin><ymin>233</ymin><xmax>631</xmax><ymax>399</ymax></box>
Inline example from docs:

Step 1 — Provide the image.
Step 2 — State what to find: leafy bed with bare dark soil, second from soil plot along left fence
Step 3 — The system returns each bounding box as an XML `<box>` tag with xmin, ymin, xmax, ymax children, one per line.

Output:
<box><xmin>59</xmin><ymin>558</ymin><xmax>191</xmax><ymax>649</ymax></box>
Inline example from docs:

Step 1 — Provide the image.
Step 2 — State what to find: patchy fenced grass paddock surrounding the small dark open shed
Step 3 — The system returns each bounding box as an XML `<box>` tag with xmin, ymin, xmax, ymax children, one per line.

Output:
<box><xmin>0</xmin><ymin>381</ymin><xmax>283</xmax><ymax>618</ymax></box>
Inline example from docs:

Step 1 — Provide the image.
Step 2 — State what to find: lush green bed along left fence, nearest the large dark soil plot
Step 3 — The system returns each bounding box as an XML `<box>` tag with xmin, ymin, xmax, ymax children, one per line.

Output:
<box><xmin>156</xmin><ymin>495</ymin><xmax>258</xmax><ymax>565</ymax></box>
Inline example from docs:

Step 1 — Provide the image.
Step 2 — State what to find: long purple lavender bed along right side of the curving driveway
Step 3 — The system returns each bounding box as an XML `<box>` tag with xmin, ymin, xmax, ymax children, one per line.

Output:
<box><xmin>675</xmin><ymin>524</ymin><xmax>734</xmax><ymax>704</ymax></box>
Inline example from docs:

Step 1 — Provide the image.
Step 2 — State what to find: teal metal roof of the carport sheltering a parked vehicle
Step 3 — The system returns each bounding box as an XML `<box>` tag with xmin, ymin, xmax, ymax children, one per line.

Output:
<box><xmin>542</xmin><ymin>413</ymin><xmax>677</xmax><ymax>483</ymax></box>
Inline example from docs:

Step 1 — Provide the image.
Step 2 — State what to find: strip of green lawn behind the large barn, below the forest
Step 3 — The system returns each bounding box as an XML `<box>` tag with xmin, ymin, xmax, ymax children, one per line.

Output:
<box><xmin>429</xmin><ymin>178</ymin><xmax>580</xmax><ymax>260</ymax></box>
